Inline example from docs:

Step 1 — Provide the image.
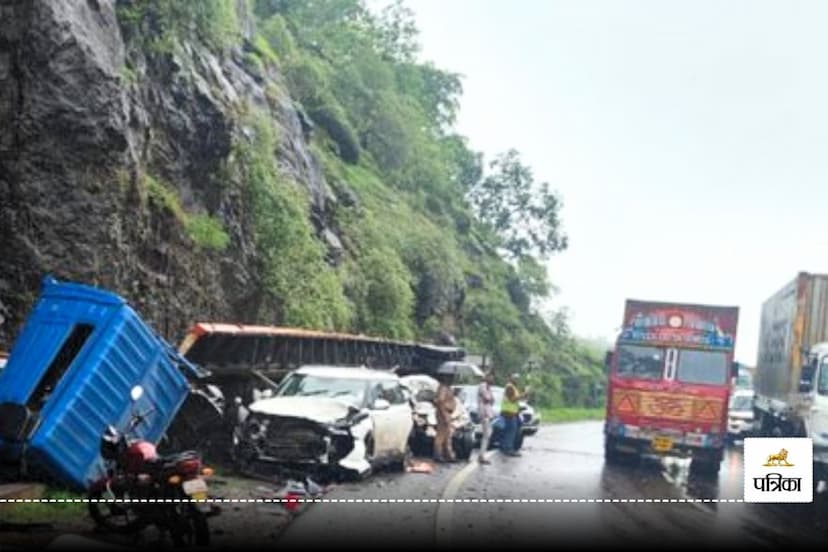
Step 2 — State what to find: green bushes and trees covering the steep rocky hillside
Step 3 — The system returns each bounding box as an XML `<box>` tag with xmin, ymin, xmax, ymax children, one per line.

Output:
<box><xmin>119</xmin><ymin>0</ymin><xmax>603</xmax><ymax>407</ymax></box>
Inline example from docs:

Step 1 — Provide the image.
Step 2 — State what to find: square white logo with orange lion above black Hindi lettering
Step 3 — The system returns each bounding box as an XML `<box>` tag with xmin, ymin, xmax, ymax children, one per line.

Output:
<box><xmin>744</xmin><ymin>437</ymin><xmax>814</xmax><ymax>502</ymax></box>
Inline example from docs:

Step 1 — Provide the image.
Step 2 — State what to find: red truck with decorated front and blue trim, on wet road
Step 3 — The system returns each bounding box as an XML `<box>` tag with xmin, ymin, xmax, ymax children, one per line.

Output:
<box><xmin>604</xmin><ymin>300</ymin><xmax>739</xmax><ymax>473</ymax></box>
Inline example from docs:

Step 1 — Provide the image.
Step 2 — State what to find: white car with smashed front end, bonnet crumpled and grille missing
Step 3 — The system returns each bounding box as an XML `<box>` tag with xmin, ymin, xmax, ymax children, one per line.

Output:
<box><xmin>234</xmin><ymin>366</ymin><xmax>413</xmax><ymax>476</ymax></box>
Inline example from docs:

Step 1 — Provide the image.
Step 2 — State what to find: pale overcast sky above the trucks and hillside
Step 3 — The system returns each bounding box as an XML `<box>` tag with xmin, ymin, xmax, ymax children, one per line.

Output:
<box><xmin>400</xmin><ymin>0</ymin><xmax>828</xmax><ymax>364</ymax></box>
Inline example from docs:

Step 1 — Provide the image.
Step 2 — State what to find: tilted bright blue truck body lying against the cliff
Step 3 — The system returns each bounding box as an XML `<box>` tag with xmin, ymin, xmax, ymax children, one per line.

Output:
<box><xmin>0</xmin><ymin>277</ymin><xmax>199</xmax><ymax>489</ymax></box>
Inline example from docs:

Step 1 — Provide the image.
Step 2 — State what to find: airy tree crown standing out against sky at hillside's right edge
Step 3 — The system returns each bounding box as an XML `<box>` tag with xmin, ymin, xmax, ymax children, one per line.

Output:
<box><xmin>469</xmin><ymin>149</ymin><xmax>567</xmax><ymax>259</ymax></box>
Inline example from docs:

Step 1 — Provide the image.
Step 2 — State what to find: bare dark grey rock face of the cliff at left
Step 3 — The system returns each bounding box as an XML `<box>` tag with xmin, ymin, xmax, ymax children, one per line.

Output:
<box><xmin>0</xmin><ymin>0</ymin><xmax>340</xmax><ymax>349</ymax></box>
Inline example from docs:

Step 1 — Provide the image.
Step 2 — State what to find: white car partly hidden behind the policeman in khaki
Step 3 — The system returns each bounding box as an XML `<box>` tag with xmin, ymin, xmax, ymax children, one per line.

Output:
<box><xmin>401</xmin><ymin>374</ymin><xmax>476</xmax><ymax>460</ymax></box>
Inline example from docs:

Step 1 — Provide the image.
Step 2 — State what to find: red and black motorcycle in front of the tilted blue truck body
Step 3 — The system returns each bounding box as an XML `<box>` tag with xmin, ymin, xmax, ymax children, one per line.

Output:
<box><xmin>88</xmin><ymin>386</ymin><xmax>219</xmax><ymax>546</ymax></box>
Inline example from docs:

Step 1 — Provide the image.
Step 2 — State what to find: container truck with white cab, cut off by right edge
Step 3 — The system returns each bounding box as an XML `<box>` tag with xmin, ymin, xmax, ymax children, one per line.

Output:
<box><xmin>754</xmin><ymin>272</ymin><xmax>828</xmax><ymax>481</ymax></box>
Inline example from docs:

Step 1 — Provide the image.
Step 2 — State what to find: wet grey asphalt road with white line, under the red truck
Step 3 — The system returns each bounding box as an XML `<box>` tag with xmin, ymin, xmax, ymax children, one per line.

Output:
<box><xmin>277</xmin><ymin>422</ymin><xmax>828</xmax><ymax>550</ymax></box>
